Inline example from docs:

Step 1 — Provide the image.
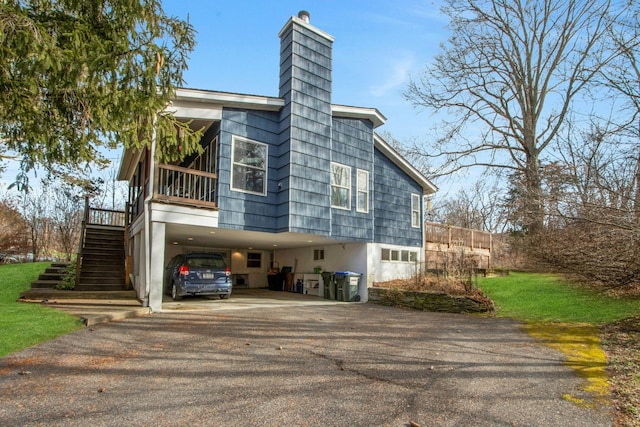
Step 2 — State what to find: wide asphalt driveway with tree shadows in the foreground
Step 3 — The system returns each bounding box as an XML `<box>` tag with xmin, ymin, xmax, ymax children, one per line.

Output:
<box><xmin>0</xmin><ymin>297</ymin><xmax>612</xmax><ymax>427</ymax></box>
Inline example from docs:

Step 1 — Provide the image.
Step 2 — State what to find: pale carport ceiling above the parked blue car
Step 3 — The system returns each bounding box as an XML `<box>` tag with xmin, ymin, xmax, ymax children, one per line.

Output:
<box><xmin>165</xmin><ymin>224</ymin><xmax>338</xmax><ymax>250</ymax></box>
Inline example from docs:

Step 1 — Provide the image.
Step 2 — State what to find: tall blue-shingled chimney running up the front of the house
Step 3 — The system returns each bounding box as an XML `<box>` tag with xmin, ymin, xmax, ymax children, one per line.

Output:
<box><xmin>276</xmin><ymin>17</ymin><xmax>332</xmax><ymax>235</ymax></box>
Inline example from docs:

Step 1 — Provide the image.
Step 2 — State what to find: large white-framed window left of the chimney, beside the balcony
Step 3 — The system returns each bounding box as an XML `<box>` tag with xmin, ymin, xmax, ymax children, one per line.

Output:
<box><xmin>231</xmin><ymin>137</ymin><xmax>267</xmax><ymax>195</ymax></box>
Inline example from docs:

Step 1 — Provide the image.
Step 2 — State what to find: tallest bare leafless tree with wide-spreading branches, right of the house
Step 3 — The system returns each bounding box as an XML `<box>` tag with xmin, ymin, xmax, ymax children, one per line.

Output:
<box><xmin>405</xmin><ymin>0</ymin><xmax>627</xmax><ymax>234</ymax></box>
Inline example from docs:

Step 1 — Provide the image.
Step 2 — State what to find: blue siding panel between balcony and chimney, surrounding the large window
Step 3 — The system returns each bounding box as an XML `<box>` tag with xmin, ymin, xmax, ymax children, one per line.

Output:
<box><xmin>218</xmin><ymin>109</ymin><xmax>282</xmax><ymax>232</ymax></box>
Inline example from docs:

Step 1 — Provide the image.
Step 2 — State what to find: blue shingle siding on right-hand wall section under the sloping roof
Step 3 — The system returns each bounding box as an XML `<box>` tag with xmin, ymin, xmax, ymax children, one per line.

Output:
<box><xmin>374</xmin><ymin>150</ymin><xmax>422</xmax><ymax>246</ymax></box>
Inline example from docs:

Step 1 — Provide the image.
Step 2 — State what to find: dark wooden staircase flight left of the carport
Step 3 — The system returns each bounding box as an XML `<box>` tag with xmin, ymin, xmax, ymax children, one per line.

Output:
<box><xmin>75</xmin><ymin>225</ymin><xmax>127</xmax><ymax>291</ymax></box>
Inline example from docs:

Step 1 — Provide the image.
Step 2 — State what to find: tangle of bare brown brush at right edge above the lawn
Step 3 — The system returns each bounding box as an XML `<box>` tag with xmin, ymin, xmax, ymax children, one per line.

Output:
<box><xmin>529</xmin><ymin>126</ymin><xmax>640</xmax><ymax>289</ymax></box>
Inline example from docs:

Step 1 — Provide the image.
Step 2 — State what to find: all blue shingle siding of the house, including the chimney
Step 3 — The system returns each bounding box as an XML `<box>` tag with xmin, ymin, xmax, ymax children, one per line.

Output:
<box><xmin>210</xmin><ymin>16</ymin><xmax>422</xmax><ymax>246</ymax></box>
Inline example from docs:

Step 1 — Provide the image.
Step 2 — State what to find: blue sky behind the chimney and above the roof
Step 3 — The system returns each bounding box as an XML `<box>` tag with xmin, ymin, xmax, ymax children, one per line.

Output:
<box><xmin>1</xmin><ymin>0</ymin><xmax>456</xmax><ymax>193</ymax></box>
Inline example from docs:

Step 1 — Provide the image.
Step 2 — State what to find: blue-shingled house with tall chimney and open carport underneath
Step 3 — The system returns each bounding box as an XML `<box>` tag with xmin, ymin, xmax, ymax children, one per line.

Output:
<box><xmin>119</xmin><ymin>12</ymin><xmax>436</xmax><ymax>310</ymax></box>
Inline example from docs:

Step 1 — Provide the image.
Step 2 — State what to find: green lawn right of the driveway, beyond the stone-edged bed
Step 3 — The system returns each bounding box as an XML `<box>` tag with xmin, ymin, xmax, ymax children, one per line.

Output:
<box><xmin>478</xmin><ymin>273</ymin><xmax>640</xmax><ymax>324</ymax></box>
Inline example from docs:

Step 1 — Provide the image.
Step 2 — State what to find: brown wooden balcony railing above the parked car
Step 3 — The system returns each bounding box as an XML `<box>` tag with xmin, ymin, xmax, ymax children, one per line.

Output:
<box><xmin>154</xmin><ymin>164</ymin><xmax>218</xmax><ymax>207</ymax></box>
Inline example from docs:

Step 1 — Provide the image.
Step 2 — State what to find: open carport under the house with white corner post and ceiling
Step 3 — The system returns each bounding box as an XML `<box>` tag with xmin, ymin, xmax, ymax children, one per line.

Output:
<box><xmin>128</xmin><ymin>201</ymin><xmax>367</xmax><ymax>311</ymax></box>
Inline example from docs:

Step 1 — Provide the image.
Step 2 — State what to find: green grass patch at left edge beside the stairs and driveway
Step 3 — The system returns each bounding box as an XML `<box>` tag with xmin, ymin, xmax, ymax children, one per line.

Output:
<box><xmin>0</xmin><ymin>262</ymin><xmax>83</xmax><ymax>357</ymax></box>
